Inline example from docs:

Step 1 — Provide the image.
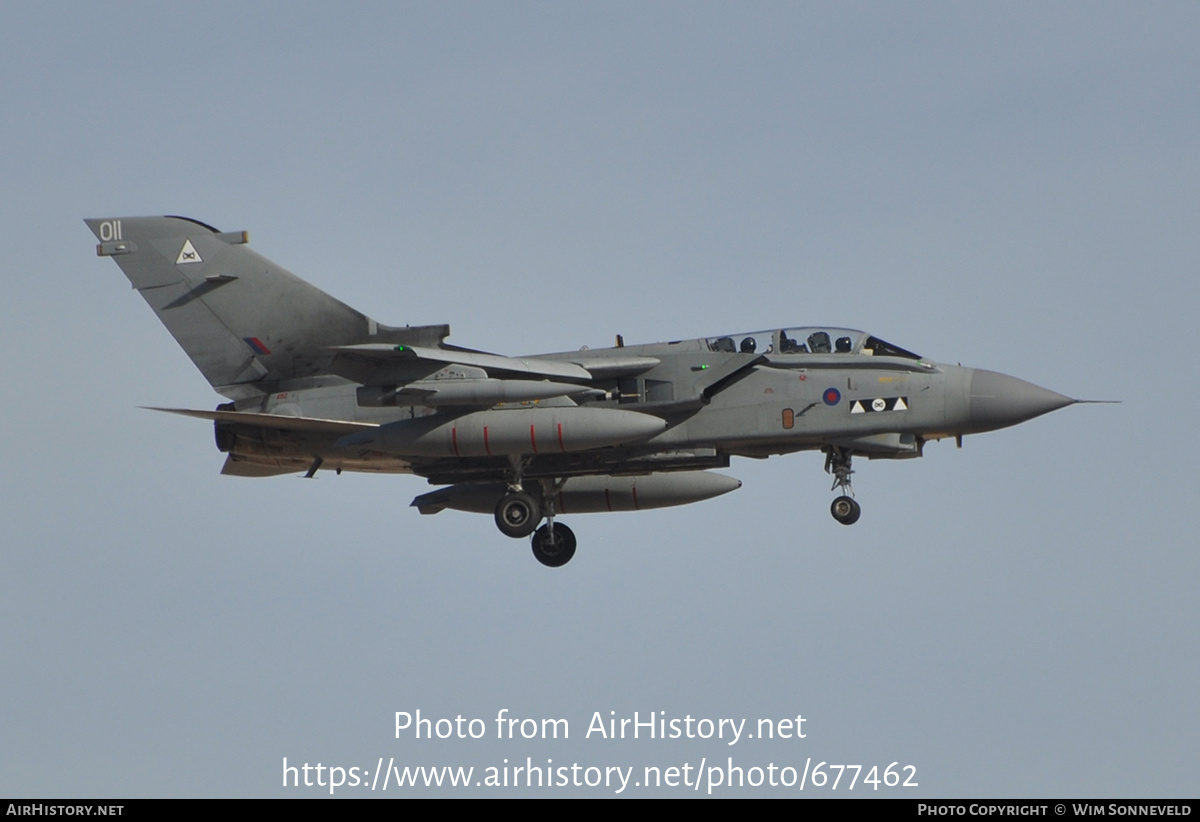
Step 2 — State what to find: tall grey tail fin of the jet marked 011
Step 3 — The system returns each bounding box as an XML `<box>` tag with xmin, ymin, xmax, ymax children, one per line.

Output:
<box><xmin>84</xmin><ymin>217</ymin><xmax>449</xmax><ymax>398</ymax></box>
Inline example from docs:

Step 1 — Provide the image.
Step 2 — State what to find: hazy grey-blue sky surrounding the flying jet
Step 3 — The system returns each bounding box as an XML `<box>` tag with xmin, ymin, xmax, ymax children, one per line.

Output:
<box><xmin>0</xmin><ymin>2</ymin><xmax>1200</xmax><ymax>798</ymax></box>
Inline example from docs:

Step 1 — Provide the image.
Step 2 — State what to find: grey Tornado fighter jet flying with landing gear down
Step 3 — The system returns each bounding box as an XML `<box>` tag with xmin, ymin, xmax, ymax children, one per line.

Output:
<box><xmin>85</xmin><ymin>217</ymin><xmax>1078</xmax><ymax>566</ymax></box>
